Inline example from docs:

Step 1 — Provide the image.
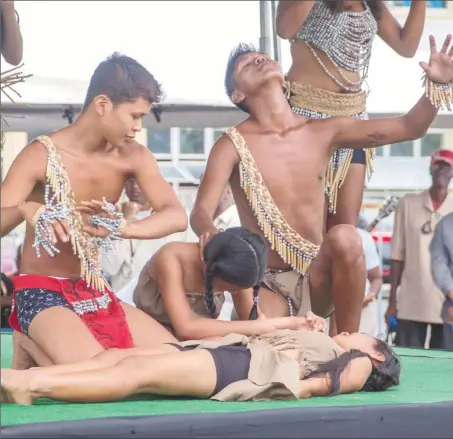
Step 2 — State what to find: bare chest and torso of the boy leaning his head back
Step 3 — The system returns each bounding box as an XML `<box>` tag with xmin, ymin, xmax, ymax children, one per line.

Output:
<box><xmin>230</xmin><ymin>115</ymin><xmax>331</xmax><ymax>268</ymax></box>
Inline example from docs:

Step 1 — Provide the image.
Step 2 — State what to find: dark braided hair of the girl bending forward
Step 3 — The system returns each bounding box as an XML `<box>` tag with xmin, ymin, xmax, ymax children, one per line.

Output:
<box><xmin>203</xmin><ymin>227</ymin><xmax>267</xmax><ymax>320</ymax></box>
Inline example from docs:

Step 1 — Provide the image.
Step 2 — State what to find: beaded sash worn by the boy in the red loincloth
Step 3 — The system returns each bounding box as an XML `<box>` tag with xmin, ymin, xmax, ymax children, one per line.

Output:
<box><xmin>35</xmin><ymin>136</ymin><xmax>110</xmax><ymax>292</ymax></box>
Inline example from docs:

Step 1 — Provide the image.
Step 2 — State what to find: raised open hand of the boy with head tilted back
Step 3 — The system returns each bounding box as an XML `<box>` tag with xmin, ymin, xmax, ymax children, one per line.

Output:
<box><xmin>420</xmin><ymin>35</ymin><xmax>453</xmax><ymax>84</ymax></box>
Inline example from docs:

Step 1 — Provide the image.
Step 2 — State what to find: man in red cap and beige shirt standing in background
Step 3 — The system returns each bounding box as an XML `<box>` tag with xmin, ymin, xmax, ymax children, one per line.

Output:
<box><xmin>386</xmin><ymin>149</ymin><xmax>453</xmax><ymax>349</ymax></box>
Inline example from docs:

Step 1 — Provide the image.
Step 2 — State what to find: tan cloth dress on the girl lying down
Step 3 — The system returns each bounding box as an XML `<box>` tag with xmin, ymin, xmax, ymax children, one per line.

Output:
<box><xmin>181</xmin><ymin>330</ymin><xmax>343</xmax><ymax>401</ymax></box>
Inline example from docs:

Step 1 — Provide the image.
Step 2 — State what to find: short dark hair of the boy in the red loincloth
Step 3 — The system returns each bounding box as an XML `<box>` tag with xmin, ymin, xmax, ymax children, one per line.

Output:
<box><xmin>83</xmin><ymin>52</ymin><xmax>163</xmax><ymax>110</ymax></box>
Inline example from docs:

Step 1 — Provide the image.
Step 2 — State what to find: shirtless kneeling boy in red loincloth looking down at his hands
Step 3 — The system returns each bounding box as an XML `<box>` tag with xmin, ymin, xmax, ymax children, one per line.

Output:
<box><xmin>1</xmin><ymin>54</ymin><xmax>187</xmax><ymax>367</ymax></box>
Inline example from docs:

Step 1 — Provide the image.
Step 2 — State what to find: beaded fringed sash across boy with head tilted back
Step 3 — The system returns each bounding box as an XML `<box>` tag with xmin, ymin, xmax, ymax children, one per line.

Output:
<box><xmin>226</xmin><ymin>128</ymin><xmax>320</xmax><ymax>276</ymax></box>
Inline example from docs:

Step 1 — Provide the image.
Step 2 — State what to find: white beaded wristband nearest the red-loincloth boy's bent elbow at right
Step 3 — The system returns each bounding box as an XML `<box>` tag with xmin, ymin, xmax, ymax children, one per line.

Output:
<box><xmin>88</xmin><ymin>198</ymin><xmax>125</xmax><ymax>254</ymax></box>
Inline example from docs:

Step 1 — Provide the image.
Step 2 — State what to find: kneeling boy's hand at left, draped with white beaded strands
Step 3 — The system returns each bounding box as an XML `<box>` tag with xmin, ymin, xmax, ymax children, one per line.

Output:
<box><xmin>18</xmin><ymin>201</ymin><xmax>71</xmax><ymax>257</ymax></box>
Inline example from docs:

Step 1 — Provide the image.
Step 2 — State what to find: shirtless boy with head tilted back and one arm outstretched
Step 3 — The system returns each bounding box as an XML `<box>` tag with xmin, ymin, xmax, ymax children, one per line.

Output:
<box><xmin>191</xmin><ymin>35</ymin><xmax>453</xmax><ymax>333</ymax></box>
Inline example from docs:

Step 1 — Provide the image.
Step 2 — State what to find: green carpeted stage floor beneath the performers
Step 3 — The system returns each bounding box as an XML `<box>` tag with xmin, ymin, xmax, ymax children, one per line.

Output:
<box><xmin>1</xmin><ymin>333</ymin><xmax>453</xmax><ymax>426</ymax></box>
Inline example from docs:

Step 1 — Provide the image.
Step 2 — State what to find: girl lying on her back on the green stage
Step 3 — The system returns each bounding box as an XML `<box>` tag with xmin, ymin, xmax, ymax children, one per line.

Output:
<box><xmin>1</xmin><ymin>330</ymin><xmax>401</xmax><ymax>404</ymax></box>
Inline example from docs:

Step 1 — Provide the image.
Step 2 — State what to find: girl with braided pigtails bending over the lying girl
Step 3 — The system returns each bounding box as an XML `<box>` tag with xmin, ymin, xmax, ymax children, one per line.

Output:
<box><xmin>133</xmin><ymin>227</ymin><xmax>326</xmax><ymax>340</ymax></box>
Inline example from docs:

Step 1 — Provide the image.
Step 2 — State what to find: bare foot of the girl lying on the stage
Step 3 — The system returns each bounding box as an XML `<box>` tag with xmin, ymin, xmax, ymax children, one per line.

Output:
<box><xmin>0</xmin><ymin>369</ymin><xmax>33</xmax><ymax>405</ymax></box>
